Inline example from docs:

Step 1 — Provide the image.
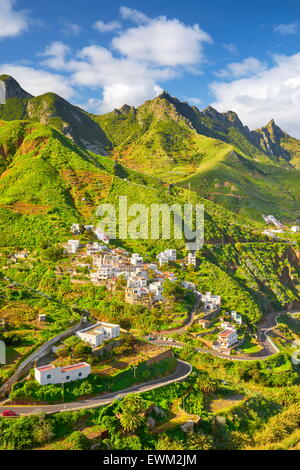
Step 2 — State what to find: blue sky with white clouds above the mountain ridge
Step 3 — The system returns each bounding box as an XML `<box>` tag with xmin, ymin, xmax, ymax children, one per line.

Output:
<box><xmin>0</xmin><ymin>0</ymin><xmax>300</xmax><ymax>138</ymax></box>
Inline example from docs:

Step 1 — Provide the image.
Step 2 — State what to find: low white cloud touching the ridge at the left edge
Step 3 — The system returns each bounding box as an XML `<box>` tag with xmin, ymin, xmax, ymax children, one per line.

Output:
<box><xmin>0</xmin><ymin>64</ymin><xmax>74</xmax><ymax>99</ymax></box>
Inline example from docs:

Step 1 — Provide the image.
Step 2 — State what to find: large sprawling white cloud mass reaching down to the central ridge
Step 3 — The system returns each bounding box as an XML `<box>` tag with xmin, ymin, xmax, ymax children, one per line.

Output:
<box><xmin>37</xmin><ymin>10</ymin><xmax>211</xmax><ymax>113</ymax></box>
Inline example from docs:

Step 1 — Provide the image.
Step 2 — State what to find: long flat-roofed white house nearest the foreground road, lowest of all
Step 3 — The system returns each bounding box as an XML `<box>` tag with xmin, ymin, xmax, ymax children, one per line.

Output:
<box><xmin>34</xmin><ymin>362</ymin><xmax>91</xmax><ymax>385</ymax></box>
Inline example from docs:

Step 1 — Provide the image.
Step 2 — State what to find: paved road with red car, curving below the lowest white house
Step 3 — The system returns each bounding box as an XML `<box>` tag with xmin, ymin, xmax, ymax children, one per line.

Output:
<box><xmin>0</xmin><ymin>360</ymin><xmax>192</xmax><ymax>415</ymax></box>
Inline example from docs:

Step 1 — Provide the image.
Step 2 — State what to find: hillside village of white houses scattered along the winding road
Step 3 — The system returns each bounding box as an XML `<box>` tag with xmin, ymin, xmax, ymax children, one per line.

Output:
<box><xmin>0</xmin><ymin>224</ymin><xmax>248</xmax><ymax>394</ymax></box>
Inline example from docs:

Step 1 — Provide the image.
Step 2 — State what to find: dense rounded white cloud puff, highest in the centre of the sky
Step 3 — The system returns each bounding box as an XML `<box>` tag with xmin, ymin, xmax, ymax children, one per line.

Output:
<box><xmin>112</xmin><ymin>17</ymin><xmax>212</xmax><ymax>66</ymax></box>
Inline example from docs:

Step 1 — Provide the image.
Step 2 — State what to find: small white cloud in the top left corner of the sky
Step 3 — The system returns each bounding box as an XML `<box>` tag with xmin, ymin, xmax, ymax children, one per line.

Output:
<box><xmin>0</xmin><ymin>0</ymin><xmax>29</xmax><ymax>38</ymax></box>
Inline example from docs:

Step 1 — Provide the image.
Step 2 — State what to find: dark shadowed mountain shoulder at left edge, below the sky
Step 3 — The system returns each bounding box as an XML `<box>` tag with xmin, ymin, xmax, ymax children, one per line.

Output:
<box><xmin>0</xmin><ymin>75</ymin><xmax>111</xmax><ymax>155</ymax></box>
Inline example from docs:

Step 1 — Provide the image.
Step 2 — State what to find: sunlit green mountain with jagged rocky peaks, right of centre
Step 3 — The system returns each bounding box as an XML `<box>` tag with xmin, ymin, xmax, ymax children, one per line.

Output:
<box><xmin>92</xmin><ymin>92</ymin><xmax>300</xmax><ymax>222</ymax></box>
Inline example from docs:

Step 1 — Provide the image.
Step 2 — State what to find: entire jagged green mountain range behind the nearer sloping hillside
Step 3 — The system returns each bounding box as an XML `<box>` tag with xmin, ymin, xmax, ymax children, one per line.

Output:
<box><xmin>0</xmin><ymin>75</ymin><xmax>300</xmax><ymax>222</ymax></box>
